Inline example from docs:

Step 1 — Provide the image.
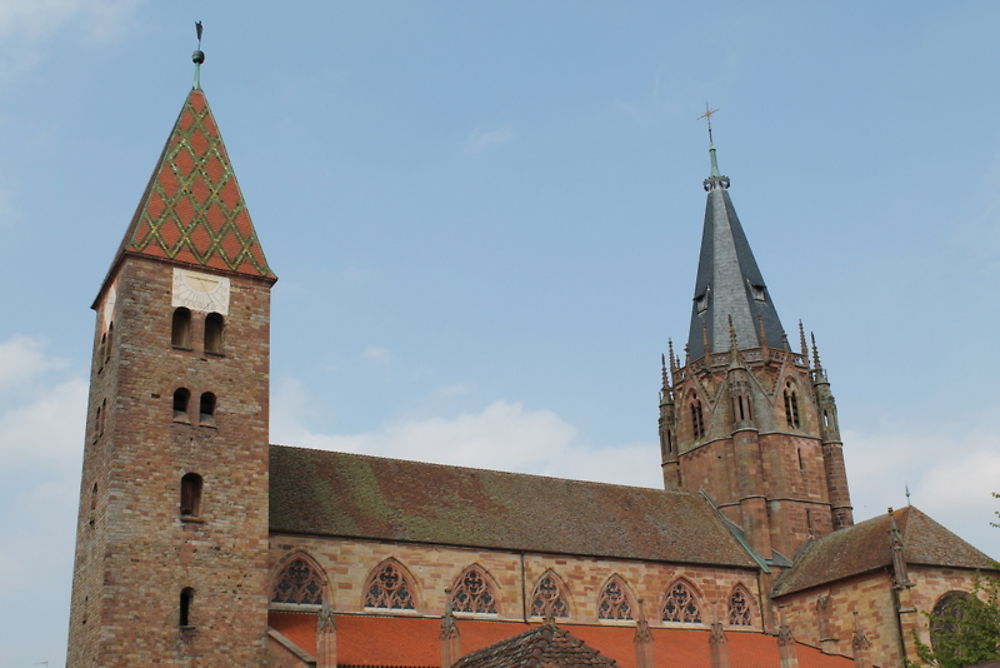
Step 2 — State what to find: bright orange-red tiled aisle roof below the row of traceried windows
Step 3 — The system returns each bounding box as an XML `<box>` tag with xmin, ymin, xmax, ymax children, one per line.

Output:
<box><xmin>269</xmin><ymin>612</ymin><xmax>853</xmax><ymax>668</ymax></box>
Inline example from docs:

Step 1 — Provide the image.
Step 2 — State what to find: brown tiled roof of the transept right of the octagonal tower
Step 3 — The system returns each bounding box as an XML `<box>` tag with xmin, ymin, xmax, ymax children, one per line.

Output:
<box><xmin>771</xmin><ymin>506</ymin><xmax>995</xmax><ymax>597</ymax></box>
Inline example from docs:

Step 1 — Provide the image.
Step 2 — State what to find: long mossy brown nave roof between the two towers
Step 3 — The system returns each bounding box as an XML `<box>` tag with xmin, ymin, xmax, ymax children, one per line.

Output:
<box><xmin>270</xmin><ymin>445</ymin><xmax>756</xmax><ymax>569</ymax></box>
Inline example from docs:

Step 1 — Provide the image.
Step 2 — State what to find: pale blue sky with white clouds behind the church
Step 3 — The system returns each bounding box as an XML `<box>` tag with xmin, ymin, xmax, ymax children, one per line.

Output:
<box><xmin>0</xmin><ymin>0</ymin><xmax>1000</xmax><ymax>666</ymax></box>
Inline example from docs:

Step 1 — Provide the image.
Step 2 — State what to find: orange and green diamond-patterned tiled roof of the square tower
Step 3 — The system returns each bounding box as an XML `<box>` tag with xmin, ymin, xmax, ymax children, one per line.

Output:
<box><xmin>115</xmin><ymin>88</ymin><xmax>276</xmax><ymax>279</ymax></box>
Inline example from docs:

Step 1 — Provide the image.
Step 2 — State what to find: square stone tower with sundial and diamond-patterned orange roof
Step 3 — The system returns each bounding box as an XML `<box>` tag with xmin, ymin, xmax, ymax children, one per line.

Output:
<box><xmin>68</xmin><ymin>51</ymin><xmax>276</xmax><ymax>666</ymax></box>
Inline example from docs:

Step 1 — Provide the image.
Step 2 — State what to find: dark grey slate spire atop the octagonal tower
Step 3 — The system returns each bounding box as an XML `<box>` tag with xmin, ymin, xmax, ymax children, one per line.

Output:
<box><xmin>688</xmin><ymin>144</ymin><xmax>788</xmax><ymax>360</ymax></box>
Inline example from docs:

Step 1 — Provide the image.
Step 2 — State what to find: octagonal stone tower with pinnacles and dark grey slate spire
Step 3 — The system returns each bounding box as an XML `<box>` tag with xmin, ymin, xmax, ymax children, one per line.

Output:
<box><xmin>660</xmin><ymin>138</ymin><xmax>853</xmax><ymax>563</ymax></box>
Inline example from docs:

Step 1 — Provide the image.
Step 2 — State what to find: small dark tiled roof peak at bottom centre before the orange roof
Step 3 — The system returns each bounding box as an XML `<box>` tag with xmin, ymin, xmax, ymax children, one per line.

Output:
<box><xmin>454</xmin><ymin>624</ymin><xmax>620</xmax><ymax>668</ymax></box>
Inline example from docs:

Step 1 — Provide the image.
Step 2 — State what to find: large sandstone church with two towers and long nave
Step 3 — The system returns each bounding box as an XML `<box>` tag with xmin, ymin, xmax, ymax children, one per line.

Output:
<box><xmin>68</xmin><ymin>51</ymin><xmax>995</xmax><ymax>668</ymax></box>
